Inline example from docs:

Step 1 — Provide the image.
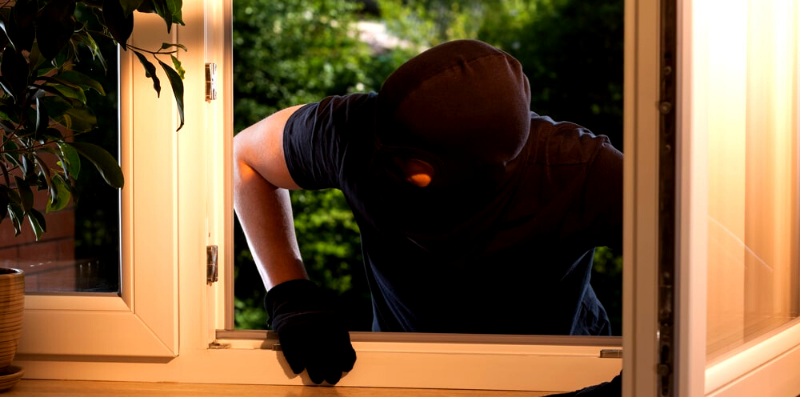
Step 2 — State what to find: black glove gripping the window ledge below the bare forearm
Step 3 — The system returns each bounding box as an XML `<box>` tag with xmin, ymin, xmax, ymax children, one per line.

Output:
<box><xmin>264</xmin><ymin>280</ymin><xmax>356</xmax><ymax>384</ymax></box>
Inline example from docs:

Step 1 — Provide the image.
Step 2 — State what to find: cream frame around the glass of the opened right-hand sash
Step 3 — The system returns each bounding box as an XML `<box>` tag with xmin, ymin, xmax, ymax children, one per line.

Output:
<box><xmin>678</xmin><ymin>1</ymin><xmax>800</xmax><ymax>397</ymax></box>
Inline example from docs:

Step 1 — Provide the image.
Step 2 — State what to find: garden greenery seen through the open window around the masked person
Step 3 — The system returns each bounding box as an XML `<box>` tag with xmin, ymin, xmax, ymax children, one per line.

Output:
<box><xmin>233</xmin><ymin>0</ymin><xmax>624</xmax><ymax>335</ymax></box>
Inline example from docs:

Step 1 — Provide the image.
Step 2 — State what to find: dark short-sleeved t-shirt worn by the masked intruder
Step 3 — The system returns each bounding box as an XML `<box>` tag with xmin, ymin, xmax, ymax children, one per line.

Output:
<box><xmin>284</xmin><ymin>93</ymin><xmax>623</xmax><ymax>335</ymax></box>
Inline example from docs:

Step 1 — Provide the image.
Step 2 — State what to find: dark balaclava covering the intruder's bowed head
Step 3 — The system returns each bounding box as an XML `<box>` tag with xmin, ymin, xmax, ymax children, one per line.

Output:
<box><xmin>373</xmin><ymin>40</ymin><xmax>531</xmax><ymax>255</ymax></box>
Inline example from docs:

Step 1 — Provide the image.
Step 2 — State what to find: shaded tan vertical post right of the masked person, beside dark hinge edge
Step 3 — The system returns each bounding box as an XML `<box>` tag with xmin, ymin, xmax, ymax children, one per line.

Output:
<box><xmin>622</xmin><ymin>0</ymin><xmax>660</xmax><ymax>397</ymax></box>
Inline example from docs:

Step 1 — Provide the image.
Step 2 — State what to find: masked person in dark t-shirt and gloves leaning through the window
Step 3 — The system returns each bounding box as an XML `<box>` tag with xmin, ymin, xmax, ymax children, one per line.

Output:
<box><xmin>234</xmin><ymin>40</ymin><xmax>623</xmax><ymax>392</ymax></box>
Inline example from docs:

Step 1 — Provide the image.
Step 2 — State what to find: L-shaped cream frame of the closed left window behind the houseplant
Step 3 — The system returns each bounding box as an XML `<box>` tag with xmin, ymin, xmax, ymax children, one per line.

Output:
<box><xmin>17</xmin><ymin>16</ymin><xmax>178</xmax><ymax>359</ymax></box>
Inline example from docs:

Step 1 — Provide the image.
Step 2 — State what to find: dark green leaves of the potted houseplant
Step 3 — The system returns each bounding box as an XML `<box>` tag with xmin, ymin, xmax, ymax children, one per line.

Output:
<box><xmin>0</xmin><ymin>0</ymin><xmax>185</xmax><ymax>239</ymax></box>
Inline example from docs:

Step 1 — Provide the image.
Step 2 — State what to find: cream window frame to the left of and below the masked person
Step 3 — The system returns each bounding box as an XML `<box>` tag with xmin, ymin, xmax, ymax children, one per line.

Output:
<box><xmin>10</xmin><ymin>0</ymin><xmax>633</xmax><ymax>391</ymax></box>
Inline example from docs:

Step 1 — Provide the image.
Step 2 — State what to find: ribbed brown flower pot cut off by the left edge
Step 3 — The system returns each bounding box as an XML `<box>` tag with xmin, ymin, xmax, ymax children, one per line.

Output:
<box><xmin>0</xmin><ymin>268</ymin><xmax>25</xmax><ymax>370</ymax></box>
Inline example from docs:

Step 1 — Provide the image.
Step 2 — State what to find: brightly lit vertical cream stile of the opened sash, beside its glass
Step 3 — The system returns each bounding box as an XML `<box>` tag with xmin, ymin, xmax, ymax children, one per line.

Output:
<box><xmin>675</xmin><ymin>1</ymin><xmax>708</xmax><ymax>397</ymax></box>
